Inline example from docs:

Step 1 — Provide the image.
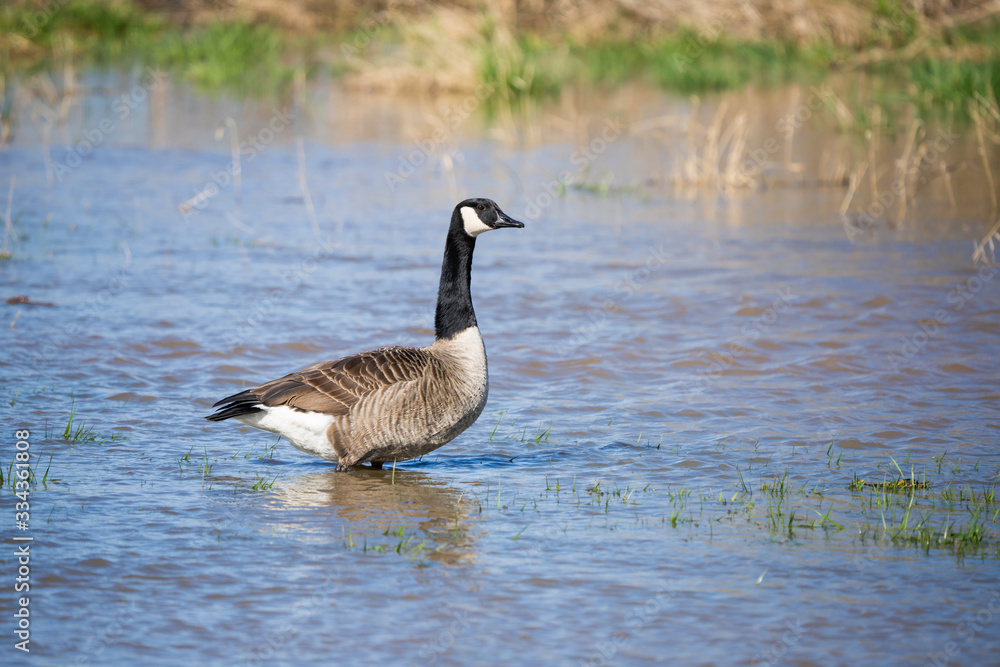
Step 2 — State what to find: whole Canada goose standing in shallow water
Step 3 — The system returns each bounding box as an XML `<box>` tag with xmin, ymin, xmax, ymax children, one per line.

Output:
<box><xmin>206</xmin><ymin>199</ymin><xmax>524</xmax><ymax>470</ymax></box>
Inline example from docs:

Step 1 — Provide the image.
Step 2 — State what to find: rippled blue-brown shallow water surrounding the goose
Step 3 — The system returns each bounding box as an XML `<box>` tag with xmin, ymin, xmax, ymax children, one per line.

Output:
<box><xmin>0</xmin><ymin>74</ymin><xmax>1000</xmax><ymax>664</ymax></box>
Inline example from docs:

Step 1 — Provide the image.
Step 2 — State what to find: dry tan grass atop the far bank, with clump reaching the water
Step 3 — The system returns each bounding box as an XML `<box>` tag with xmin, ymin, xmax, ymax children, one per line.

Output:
<box><xmin>111</xmin><ymin>0</ymin><xmax>1000</xmax><ymax>92</ymax></box>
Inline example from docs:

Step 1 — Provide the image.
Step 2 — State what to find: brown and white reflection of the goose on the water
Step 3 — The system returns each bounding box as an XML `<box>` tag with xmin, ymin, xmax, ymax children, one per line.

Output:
<box><xmin>271</xmin><ymin>468</ymin><xmax>480</xmax><ymax>565</ymax></box>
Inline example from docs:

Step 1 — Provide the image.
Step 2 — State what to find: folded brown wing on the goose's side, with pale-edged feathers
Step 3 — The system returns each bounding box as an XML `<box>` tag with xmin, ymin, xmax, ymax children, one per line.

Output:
<box><xmin>251</xmin><ymin>347</ymin><xmax>433</xmax><ymax>415</ymax></box>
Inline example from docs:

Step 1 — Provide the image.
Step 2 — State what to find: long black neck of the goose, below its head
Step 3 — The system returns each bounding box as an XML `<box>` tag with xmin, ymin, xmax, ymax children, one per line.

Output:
<box><xmin>434</xmin><ymin>225</ymin><xmax>476</xmax><ymax>338</ymax></box>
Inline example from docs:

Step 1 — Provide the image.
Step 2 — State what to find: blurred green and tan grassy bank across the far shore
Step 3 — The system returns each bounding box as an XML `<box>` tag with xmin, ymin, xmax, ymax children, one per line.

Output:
<box><xmin>0</xmin><ymin>0</ymin><xmax>1000</xmax><ymax>109</ymax></box>
